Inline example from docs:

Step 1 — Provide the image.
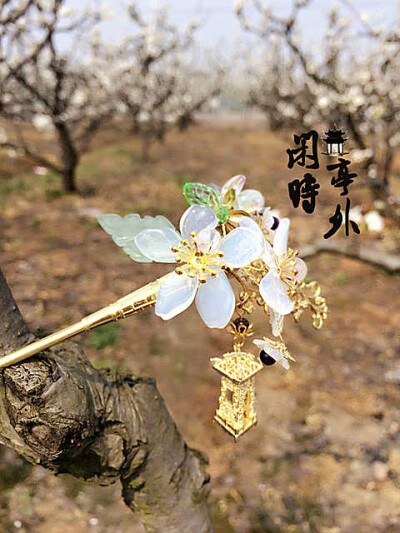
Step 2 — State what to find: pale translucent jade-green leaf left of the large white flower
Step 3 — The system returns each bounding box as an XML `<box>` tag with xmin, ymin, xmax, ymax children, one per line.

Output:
<box><xmin>97</xmin><ymin>214</ymin><xmax>176</xmax><ymax>263</ymax></box>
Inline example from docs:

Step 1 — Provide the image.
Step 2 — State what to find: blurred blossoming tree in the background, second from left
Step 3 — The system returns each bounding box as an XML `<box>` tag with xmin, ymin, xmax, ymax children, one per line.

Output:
<box><xmin>114</xmin><ymin>2</ymin><xmax>224</xmax><ymax>159</ymax></box>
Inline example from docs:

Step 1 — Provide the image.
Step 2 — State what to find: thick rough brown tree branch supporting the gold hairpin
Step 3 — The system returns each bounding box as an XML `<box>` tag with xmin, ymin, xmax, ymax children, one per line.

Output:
<box><xmin>0</xmin><ymin>270</ymin><xmax>213</xmax><ymax>533</ymax></box>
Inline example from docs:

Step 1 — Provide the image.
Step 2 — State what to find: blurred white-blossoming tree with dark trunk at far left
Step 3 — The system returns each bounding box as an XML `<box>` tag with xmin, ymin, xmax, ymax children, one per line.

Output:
<box><xmin>0</xmin><ymin>0</ymin><xmax>114</xmax><ymax>192</ymax></box>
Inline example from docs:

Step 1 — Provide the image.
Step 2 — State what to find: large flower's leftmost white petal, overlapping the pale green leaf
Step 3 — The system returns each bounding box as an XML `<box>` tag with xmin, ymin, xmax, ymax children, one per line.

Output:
<box><xmin>135</xmin><ymin>228</ymin><xmax>181</xmax><ymax>263</ymax></box>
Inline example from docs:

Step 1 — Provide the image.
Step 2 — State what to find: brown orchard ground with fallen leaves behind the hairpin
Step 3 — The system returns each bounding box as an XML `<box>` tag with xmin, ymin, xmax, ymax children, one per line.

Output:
<box><xmin>0</xmin><ymin>121</ymin><xmax>400</xmax><ymax>533</ymax></box>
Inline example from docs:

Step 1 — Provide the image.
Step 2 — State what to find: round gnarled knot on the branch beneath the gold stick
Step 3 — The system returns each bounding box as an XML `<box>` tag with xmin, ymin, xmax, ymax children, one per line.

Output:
<box><xmin>3</xmin><ymin>343</ymin><xmax>102</xmax><ymax>465</ymax></box>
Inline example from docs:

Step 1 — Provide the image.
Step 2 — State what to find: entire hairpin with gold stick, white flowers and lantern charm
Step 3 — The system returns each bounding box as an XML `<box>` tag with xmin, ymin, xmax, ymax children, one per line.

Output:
<box><xmin>0</xmin><ymin>176</ymin><xmax>328</xmax><ymax>439</ymax></box>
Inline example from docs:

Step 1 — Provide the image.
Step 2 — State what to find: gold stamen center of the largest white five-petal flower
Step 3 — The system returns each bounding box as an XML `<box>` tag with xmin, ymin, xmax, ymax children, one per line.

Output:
<box><xmin>171</xmin><ymin>232</ymin><xmax>224</xmax><ymax>283</ymax></box>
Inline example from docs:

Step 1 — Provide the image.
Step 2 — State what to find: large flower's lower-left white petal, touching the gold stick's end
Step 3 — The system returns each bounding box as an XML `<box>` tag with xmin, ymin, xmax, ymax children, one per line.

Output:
<box><xmin>155</xmin><ymin>272</ymin><xmax>198</xmax><ymax>320</ymax></box>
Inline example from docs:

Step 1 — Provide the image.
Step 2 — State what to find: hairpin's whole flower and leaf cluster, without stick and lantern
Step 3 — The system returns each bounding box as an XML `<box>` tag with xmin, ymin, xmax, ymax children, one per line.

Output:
<box><xmin>98</xmin><ymin>175</ymin><xmax>327</xmax><ymax>368</ymax></box>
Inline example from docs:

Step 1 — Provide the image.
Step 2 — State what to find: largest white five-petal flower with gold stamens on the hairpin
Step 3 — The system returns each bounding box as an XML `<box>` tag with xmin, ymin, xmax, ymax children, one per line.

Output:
<box><xmin>99</xmin><ymin>205</ymin><xmax>263</xmax><ymax>328</ymax></box>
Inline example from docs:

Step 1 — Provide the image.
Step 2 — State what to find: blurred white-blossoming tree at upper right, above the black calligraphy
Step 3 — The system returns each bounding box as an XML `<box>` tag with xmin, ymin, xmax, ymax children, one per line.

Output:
<box><xmin>236</xmin><ymin>0</ymin><xmax>400</xmax><ymax>223</ymax></box>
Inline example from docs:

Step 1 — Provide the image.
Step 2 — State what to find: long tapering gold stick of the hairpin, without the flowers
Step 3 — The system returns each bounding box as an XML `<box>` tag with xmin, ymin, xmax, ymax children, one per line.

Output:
<box><xmin>0</xmin><ymin>274</ymin><xmax>170</xmax><ymax>368</ymax></box>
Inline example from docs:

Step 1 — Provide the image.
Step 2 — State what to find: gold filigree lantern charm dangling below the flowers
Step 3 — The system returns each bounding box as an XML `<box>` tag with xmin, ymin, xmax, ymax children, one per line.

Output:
<box><xmin>211</xmin><ymin>351</ymin><xmax>263</xmax><ymax>439</ymax></box>
